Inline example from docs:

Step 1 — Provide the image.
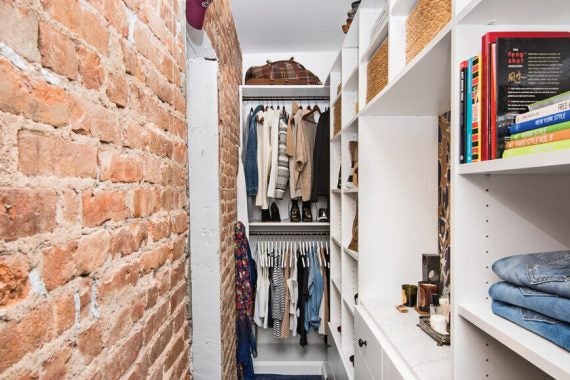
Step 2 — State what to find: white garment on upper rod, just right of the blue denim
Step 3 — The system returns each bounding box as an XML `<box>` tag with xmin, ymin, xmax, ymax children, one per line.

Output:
<box><xmin>255</xmin><ymin>109</ymin><xmax>274</xmax><ymax>210</ymax></box>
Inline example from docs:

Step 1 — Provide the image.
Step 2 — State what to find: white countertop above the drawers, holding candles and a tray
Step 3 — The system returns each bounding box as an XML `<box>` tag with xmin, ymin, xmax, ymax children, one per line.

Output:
<box><xmin>358</xmin><ymin>300</ymin><xmax>452</xmax><ymax>380</ymax></box>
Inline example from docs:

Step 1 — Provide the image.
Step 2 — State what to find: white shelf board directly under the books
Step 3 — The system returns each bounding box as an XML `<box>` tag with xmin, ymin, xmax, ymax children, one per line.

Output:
<box><xmin>458</xmin><ymin>149</ymin><xmax>570</xmax><ymax>174</ymax></box>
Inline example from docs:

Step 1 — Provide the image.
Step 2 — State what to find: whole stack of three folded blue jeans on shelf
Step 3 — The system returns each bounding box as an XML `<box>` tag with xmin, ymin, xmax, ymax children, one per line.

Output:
<box><xmin>489</xmin><ymin>251</ymin><xmax>570</xmax><ymax>351</ymax></box>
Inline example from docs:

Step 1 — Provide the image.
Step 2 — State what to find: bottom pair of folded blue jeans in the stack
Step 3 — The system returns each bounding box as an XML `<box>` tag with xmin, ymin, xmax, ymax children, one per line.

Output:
<box><xmin>492</xmin><ymin>301</ymin><xmax>570</xmax><ymax>351</ymax></box>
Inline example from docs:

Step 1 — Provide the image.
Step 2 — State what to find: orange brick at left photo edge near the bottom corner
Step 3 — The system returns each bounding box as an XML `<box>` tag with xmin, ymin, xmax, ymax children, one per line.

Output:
<box><xmin>0</xmin><ymin>303</ymin><xmax>53</xmax><ymax>373</ymax></box>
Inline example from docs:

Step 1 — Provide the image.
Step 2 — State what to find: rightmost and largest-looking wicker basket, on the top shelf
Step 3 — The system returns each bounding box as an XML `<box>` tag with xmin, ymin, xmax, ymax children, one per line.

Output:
<box><xmin>406</xmin><ymin>0</ymin><xmax>451</xmax><ymax>62</ymax></box>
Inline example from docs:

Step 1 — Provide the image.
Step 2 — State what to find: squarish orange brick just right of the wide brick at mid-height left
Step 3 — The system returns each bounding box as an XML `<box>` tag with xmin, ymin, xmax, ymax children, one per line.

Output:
<box><xmin>99</xmin><ymin>151</ymin><xmax>143</xmax><ymax>182</ymax></box>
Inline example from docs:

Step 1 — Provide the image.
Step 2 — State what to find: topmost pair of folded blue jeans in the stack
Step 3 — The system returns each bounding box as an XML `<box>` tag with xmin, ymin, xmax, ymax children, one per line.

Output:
<box><xmin>493</xmin><ymin>251</ymin><xmax>570</xmax><ymax>298</ymax></box>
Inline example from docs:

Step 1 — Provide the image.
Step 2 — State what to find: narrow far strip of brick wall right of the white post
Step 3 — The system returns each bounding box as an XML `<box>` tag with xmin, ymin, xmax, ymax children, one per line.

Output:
<box><xmin>204</xmin><ymin>0</ymin><xmax>242</xmax><ymax>379</ymax></box>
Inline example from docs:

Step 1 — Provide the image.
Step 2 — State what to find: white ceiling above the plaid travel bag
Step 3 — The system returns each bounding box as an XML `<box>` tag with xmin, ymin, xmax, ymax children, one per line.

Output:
<box><xmin>231</xmin><ymin>0</ymin><xmax>351</xmax><ymax>54</ymax></box>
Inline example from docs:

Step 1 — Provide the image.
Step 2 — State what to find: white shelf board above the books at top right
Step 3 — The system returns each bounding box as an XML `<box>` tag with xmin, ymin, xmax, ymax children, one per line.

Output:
<box><xmin>457</xmin><ymin>0</ymin><xmax>570</xmax><ymax>25</ymax></box>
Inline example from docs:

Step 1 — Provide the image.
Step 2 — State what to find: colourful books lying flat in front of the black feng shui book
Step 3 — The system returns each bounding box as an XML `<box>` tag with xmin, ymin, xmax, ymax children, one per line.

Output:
<box><xmin>503</xmin><ymin>91</ymin><xmax>570</xmax><ymax>158</ymax></box>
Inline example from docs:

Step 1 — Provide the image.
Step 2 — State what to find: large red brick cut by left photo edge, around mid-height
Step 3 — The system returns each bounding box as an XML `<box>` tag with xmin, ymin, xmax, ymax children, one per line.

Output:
<box><xmin>0</xmin><ymin>187</ymin><xmax>56</xmax><ymax>240</ymax></box>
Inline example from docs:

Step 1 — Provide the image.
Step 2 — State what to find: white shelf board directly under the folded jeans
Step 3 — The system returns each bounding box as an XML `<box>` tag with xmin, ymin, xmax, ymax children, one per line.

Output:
<box><xmin>457</xmin><ymin>304</ymin><xmax>570</xmax><ymax>379</ymax></box>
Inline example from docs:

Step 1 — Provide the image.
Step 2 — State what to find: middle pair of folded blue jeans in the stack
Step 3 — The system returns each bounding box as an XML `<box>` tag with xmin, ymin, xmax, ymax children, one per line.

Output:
<box><xmin>489</xmin><ymin>281</ymin><xmax>570</xmax><ymax>323</ymax></box>
